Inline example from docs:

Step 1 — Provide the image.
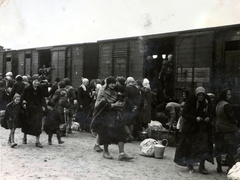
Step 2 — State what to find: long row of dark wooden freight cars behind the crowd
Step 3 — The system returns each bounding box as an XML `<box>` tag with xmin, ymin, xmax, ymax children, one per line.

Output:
<box><xmin>0</xmin><ymin>24</ymin><xmax>240</xmax><ymax>102</ymax></box>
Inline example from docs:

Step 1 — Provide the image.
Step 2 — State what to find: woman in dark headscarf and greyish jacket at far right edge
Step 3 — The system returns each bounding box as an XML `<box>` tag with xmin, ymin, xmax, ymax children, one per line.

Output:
<box><xmin>215</xmin><ymin>89</ymin><xmax>239</xmax><ymax>173</ymax></box>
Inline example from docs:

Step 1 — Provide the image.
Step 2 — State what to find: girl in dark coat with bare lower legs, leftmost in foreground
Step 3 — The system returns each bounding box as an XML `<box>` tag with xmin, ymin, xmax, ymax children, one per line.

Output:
<box><xmin>5</xmin><ymin>93</ymin><xmax>22</xmax><ymax>148</ymax></box>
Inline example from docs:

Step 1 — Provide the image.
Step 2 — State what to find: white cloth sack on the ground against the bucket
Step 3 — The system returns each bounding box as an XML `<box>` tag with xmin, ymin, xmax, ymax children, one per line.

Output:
<box><xmin>139</xmin><ymin>138</ymin><xmax>158</xmax><ymax>157</ymax></box>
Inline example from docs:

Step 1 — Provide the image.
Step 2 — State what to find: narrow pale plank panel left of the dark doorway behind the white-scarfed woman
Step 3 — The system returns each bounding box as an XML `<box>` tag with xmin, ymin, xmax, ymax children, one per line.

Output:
<box><xmin>71</xmin><ymin>45</ymin><xmax>83</xmax><ymax>89</ymax></box>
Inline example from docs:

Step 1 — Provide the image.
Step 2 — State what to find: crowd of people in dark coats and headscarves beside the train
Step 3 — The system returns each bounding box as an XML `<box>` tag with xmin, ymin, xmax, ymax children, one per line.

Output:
<box><xmin>0</xmin><ymin>64</ymin><xmax>239</xmax><ymax>174</ymax></box>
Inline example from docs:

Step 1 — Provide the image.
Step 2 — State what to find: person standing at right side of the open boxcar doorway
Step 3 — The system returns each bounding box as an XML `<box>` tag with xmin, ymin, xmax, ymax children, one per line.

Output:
<box><xmin>158</xmin><ymin>54</ymin><xmax>174</xmax><ymax>99</ymax></box>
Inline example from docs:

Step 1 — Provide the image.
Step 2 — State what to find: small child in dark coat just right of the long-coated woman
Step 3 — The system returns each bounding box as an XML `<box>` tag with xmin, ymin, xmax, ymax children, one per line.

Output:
<box><xmin>44</xmin><ymin>101</ymin><xmax>64</xmax><ymax>145</ymax></box>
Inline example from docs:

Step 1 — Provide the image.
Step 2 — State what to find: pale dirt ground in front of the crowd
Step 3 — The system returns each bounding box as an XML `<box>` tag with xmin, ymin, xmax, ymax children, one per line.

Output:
<box><xmin>0</xmin><ymin>128</ymin><xmax>227</xmax><ymax>180</ymax></box>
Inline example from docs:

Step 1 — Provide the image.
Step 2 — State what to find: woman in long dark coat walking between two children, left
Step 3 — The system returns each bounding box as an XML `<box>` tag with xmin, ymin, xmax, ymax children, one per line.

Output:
<box><xmin>21</xmin><ymin>74</ymin><xmax>46</xmax><ymax>148</ymax></box>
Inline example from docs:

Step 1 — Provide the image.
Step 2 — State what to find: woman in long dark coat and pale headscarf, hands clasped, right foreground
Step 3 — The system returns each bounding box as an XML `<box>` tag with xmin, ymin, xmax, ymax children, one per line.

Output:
<box><xmin>174</xmin><ymin>87</ymin><xmax>213</xmax><ymax>174</ymax></box>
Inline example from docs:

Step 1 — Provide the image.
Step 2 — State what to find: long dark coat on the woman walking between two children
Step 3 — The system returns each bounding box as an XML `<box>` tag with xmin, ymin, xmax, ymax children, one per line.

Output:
<box><xmin>21</xmin><ymin>84</ymin><xmax>46</xmax><ymax>136</ymax></box>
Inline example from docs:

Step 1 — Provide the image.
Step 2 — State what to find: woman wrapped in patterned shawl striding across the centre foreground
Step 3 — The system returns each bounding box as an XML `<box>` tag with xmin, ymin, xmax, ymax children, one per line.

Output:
<box><xmin>91</xmin><ymin>76</ymin><xmax>133</xmax><ymax>161</ymax></box>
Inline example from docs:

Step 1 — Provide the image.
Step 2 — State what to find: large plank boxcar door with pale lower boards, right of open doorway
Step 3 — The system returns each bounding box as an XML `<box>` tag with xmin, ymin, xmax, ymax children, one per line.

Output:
<box><xmin>176</xmin><ymin>32</ymin><xmax>213</xmax><ymax>91</ymax></box>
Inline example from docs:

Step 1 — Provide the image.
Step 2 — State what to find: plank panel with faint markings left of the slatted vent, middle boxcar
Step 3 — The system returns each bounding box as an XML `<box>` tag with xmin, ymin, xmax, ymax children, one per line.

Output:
<box><xmin>98</xmin><ymin>42</ymin><xmax>113</xmax><ymax>79</ymax></box>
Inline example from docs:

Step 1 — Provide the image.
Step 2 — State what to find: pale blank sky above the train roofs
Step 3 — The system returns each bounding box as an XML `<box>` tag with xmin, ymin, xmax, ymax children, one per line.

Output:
<box><xmin>0</xmin><ymin>0</ymin><xmax>240</xmax><ymax>49</ymax></box>
